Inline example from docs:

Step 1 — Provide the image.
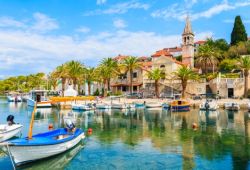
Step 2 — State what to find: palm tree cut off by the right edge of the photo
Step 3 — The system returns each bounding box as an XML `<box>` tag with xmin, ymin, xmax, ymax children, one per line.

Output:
<box><xmin>239</xmin><ymin>56</ymin><xmax>250</xmax><ymax>98</ymax></box>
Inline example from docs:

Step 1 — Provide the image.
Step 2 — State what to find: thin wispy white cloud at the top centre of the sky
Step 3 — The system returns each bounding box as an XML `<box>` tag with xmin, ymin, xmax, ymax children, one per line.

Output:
<box><xmin>83</xmin><ymin>1</ymin><xmax>150</xmax><ymax>16</ymax></box>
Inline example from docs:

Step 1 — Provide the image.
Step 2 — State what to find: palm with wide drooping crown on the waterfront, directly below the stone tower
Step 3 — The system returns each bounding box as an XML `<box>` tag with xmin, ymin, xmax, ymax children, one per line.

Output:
<box><xmin>172</xmin><ymin>65</ymin><xmax>199</xmax><ymax>98</ymax></box>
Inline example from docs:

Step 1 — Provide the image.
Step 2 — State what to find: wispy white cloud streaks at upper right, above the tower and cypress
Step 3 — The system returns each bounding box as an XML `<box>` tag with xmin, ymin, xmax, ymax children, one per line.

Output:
<box><xmin>151</xmin><ymin>0</ymin><xmax>250</xmax><ymax>21</ymax></box>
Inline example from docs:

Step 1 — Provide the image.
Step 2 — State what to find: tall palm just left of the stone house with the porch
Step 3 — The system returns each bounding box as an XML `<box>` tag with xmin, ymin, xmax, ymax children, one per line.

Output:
<box><xmin>101</xmin><ymin>58</ymin><xmax>118</xmax><ymax>91</ymax></box>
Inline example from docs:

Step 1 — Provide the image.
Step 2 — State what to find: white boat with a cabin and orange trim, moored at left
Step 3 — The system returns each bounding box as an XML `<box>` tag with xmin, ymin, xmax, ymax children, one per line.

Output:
<box><xmin>27</xmin><ymin>90</ymin><xmax>52</xmax><ymax>107</ymax></box>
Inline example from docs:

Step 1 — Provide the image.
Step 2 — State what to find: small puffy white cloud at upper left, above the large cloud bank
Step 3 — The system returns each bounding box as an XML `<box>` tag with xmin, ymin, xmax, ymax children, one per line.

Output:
<box><xmin>32</xmin><ymin>12</ymin><xmax>59</xmax><ymax>32</ymax></box>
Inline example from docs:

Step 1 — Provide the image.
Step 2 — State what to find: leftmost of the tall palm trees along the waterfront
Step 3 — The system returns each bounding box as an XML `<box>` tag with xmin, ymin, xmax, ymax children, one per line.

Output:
<box><xmin>54</xmin><ymin>64</ymin><xmax>69</xmax><ymax>95</ymax></box>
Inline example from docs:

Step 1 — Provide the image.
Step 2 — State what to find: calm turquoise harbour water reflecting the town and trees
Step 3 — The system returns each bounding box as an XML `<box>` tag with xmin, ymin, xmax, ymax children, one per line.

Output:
<box><xmin>0</xmin><ymin>98</ymin><xmax>250</xmax><ymax>170</ymax></box>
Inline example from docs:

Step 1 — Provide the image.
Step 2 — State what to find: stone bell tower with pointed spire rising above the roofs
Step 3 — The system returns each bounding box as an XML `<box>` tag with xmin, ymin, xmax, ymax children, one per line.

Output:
<box><xmin>182</xmin><ymin>16</ymin><xmax>194</xmax><ymax>68</ymax></box>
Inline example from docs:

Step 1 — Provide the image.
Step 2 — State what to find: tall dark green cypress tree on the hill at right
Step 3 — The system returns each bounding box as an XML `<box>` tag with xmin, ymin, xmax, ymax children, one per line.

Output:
<box><xmin>231</xmin><ymin>16</ymin><xmax>247</xmax><ymax>45</ymax></box>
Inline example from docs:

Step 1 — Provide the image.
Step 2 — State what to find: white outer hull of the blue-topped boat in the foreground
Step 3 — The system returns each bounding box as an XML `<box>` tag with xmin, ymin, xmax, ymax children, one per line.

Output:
<box><xmin>9</xmin><ymin>133</ymin><xmax>85</xmax><ymax>165</ymax></box>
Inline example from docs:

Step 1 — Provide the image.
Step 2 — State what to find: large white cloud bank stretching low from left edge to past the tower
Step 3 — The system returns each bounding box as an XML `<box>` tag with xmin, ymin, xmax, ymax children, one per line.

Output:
<box><xmin>0</xmin><ymin>26</ymin><xmax>211</xmax><ymax>74</ymax></box>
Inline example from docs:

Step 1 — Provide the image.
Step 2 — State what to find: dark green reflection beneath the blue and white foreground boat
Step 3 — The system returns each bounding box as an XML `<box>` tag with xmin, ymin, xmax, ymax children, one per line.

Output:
<box><xmin>19</xmin><ymin>142</ymin><xmax>84</xmax><ymax>170</ymax></box>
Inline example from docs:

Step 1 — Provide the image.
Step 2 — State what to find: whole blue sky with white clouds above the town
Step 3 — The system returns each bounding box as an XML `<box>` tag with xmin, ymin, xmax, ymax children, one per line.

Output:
<box><xmin>0</xmin><ymin>0</ymin><xmax>250</xmax><ymax>79</ymax></box>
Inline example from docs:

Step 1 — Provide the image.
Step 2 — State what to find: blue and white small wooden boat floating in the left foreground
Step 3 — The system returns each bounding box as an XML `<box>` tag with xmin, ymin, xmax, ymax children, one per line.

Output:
<box><xmin>6</xmin><ymin>128</ymin><xmax>85</xmax><ymax>165</ymax></box>
